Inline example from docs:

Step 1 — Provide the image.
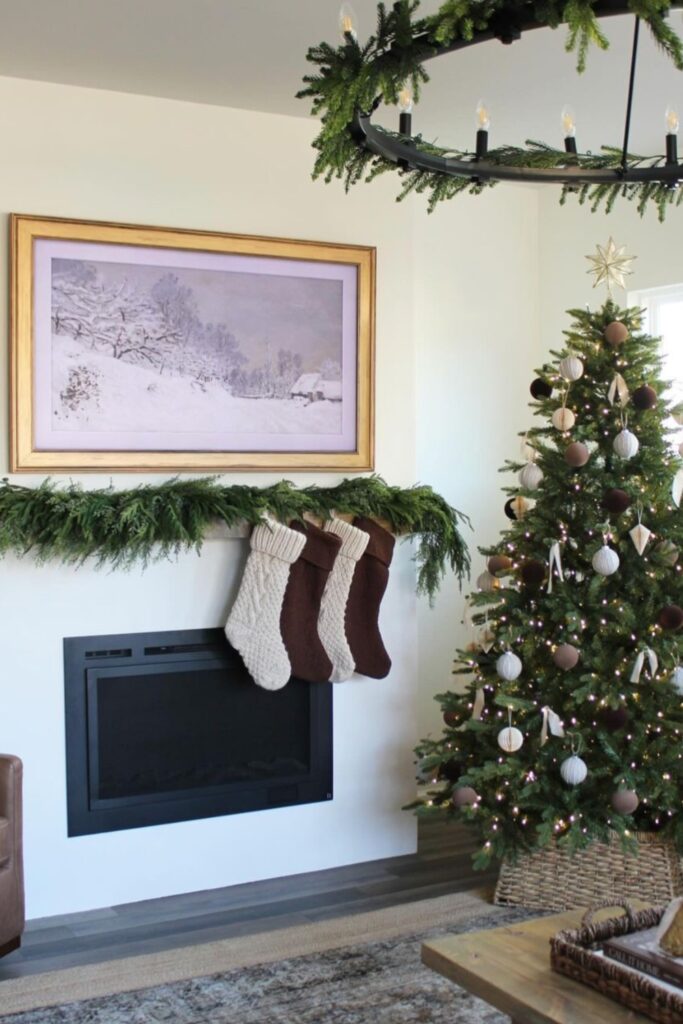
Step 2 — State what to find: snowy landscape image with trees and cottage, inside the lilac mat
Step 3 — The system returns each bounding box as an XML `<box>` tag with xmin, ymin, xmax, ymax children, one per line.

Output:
<box><xmin>51</xmin><ymin>259</ymin><xmax>342</xmax><ymax>434</ymax></box>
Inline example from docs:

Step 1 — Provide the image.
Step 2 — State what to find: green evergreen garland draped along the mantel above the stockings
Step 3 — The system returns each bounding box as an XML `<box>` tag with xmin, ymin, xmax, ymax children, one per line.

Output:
<box><xmin>0</xmin><ymin>476</ymin><xmax>470</xmax><ymax>600</ymax></box>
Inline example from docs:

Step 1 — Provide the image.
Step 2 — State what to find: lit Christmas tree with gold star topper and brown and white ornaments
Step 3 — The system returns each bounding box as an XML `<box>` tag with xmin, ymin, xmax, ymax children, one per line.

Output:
<box><xmin>415</xmin><ymin>240</ymin><xmax>683</xmax><ymax>866</ymax></box>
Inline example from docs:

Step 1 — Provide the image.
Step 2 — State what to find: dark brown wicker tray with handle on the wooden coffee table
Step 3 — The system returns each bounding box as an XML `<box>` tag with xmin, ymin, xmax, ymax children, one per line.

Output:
<box><xmin>550</xmin><ymin>901</ymin><xmax>683</xmax><ymax>1024</ymax></box>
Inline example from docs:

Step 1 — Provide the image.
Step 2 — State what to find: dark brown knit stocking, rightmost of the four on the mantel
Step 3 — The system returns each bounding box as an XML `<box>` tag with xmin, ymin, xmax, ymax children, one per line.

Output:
<box><xmin>345</xmin><ymin>516</ymin><xmax>395</xmax><ymax>679</ymax></box>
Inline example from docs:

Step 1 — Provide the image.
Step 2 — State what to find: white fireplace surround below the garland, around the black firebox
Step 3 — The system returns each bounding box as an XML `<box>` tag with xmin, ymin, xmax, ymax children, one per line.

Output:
<box><xmin>2</xmin><ymin>541</ymin><xmax>417</xmax><ymax>916</ymax></box>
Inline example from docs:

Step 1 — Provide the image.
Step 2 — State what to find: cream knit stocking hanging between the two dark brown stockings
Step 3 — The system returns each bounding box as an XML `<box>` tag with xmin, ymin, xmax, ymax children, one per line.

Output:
<box><xmin>317</xmin><ymin>519</ymin><xmax>370</xmax><ymax>683</ymax></box>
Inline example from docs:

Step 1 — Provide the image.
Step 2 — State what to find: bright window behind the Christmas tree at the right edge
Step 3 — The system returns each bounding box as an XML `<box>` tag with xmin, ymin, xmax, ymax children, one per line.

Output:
<box><xmin>629</xmin><ymin>284</ymin><xmax>683</xmax><ymax>444</ymax></box>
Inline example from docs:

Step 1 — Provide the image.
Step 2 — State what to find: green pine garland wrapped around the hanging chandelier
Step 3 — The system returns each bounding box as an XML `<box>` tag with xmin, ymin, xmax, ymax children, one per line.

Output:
<box><xmin>297</xmin><ymin>0</ymin><xmax>683</xmax><ymax>220</ymax></box>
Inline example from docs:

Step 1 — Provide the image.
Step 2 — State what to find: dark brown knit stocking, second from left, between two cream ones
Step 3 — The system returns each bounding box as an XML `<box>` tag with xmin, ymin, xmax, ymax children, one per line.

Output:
<box><xmin>280</xmin><ymin>522</ymin><xmax>342</xmax><ymax>683</ymax></box>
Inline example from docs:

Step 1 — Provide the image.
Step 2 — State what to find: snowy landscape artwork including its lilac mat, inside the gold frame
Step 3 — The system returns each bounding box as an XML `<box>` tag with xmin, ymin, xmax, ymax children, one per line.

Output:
<box><xmin>12</xmin><ymin>218</ymin><xmax>374</xmax><ymax>468</ymax></box>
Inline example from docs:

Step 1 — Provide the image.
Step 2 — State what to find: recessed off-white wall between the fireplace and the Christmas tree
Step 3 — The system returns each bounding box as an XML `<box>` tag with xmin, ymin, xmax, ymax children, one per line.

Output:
<box><xmin>415</xmin><ymin>185</ymin><xmax>539</xmax><ymax>736</ymax></box>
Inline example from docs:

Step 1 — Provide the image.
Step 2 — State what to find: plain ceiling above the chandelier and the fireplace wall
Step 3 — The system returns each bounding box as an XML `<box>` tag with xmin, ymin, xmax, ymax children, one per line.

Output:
<box><xmin>0</xmin><ymin>0</ymin><xmax>683</xmax><ymax>153</ymax></box>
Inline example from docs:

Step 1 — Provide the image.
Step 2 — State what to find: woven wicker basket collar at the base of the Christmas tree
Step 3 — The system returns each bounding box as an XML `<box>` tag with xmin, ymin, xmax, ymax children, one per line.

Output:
<box><xmin>494</xmin><ymin>833</ymin><xmax>683</xmax><ymax>910</ymax></box>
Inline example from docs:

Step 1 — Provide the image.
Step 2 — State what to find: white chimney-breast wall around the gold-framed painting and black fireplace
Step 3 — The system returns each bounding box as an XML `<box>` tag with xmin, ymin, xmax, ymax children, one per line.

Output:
<box><xmin>0</xmin><ymin>79</ymin><xmax>417</xmax><ymax>916</ymax></box>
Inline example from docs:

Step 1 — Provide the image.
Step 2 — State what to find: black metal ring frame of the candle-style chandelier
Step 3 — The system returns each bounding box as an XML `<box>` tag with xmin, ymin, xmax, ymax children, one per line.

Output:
<box><xmin>350</xmin><ymin>0</ymin><xmax>683</xmax><ymax>189</ymax></box>
